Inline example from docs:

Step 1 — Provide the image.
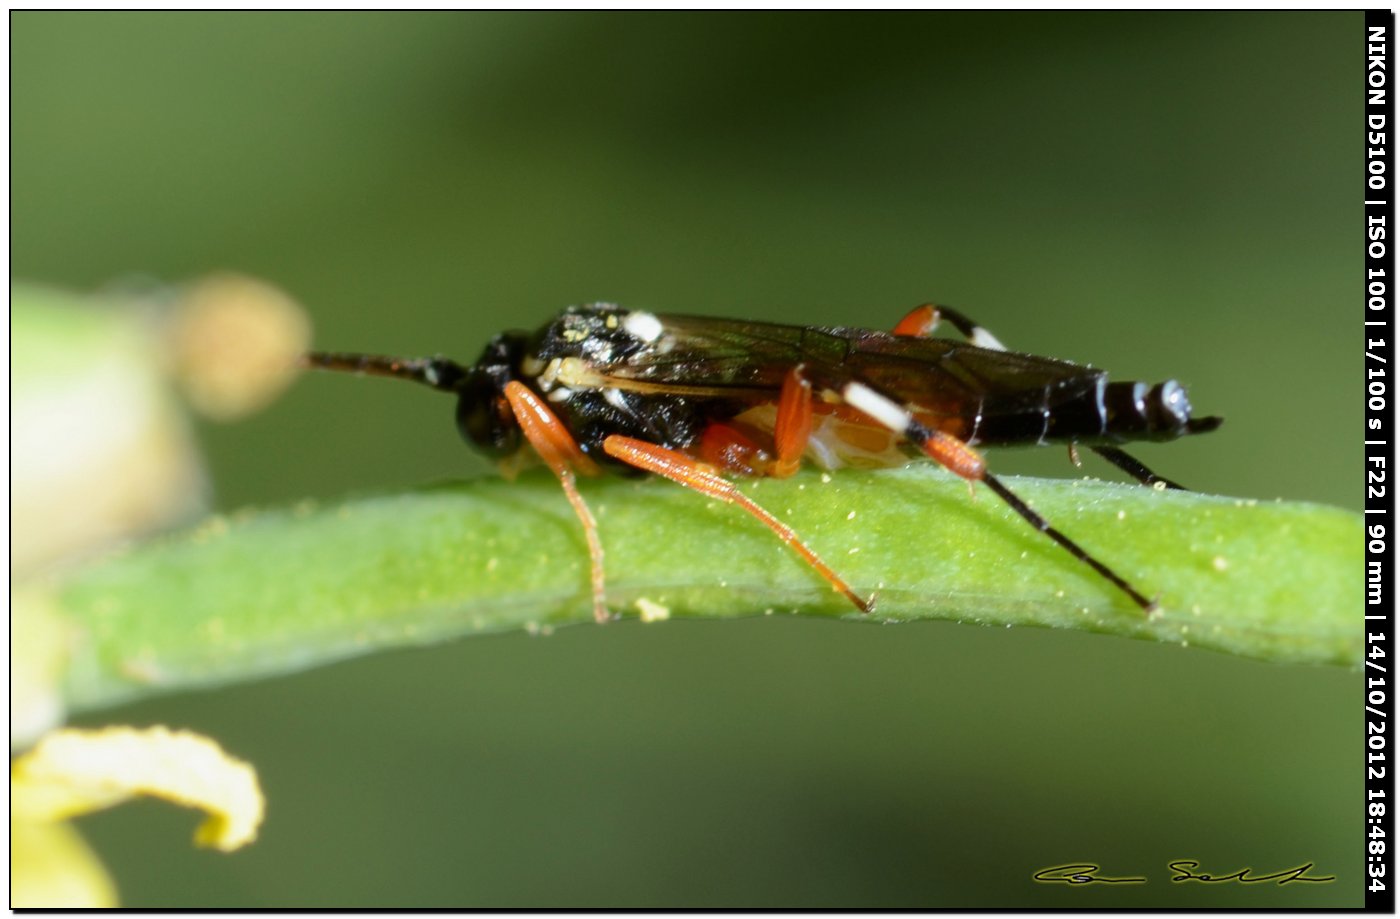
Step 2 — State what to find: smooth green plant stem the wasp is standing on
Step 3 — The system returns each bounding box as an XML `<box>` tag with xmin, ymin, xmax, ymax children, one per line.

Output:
<box><xmin>53</xmin><ymin>465</ymin><xmax>1362</xmax><ymax>709</ymax></box>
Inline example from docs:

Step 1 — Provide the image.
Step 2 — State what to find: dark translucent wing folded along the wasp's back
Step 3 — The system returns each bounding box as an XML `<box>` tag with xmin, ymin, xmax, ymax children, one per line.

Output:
<box><xmin>599</xmin><ymin>315</ymin><xmax>1103</xmax><ymax>417</ymax></box>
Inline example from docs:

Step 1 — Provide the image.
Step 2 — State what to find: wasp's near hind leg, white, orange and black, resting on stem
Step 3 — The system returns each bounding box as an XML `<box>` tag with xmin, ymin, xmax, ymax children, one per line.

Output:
<box><xmin>841</xmin><ymin>381</ymin><xmax>1156</xmax><ymax>612</ymax></box>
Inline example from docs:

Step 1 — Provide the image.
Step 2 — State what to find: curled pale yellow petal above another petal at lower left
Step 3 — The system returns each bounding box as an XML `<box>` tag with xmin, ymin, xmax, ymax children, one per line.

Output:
<box><xmin>10</xmin><ymin>727</ymin><xmax>263</xmax><ymax>852</ymax></box>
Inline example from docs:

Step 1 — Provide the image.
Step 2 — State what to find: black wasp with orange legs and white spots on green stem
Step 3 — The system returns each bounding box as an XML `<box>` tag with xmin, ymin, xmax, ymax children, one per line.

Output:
<box><xmin>302</xmin><ymin>303</ymin><xmax>1221</xmax><ymax>622</ymax></box>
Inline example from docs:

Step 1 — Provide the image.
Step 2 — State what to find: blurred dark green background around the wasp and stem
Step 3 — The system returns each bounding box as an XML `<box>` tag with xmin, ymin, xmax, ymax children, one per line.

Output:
<box><xmin>11</xmin><ymin>13</ymin><xmax>1362</xmax><ymax>908</ymax></box>
